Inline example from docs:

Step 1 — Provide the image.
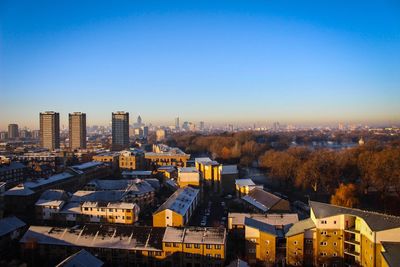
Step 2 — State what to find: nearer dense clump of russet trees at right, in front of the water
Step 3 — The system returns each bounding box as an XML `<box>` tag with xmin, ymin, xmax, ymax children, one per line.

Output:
<box><xmin>259</xmin><ymin>143</ymin><xmax>400</xmax><ymax>209</ymax></box>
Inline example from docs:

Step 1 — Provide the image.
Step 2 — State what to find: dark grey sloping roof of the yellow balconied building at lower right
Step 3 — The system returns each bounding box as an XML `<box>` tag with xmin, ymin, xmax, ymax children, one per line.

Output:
<box><xmin>309</xmin><ymin>201</ymin><xmax>400</xmax><ymax>231</ymax></box>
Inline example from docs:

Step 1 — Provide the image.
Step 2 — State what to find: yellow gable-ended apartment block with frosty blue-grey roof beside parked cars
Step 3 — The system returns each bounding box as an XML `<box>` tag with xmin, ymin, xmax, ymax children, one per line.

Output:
<box><xmin>153</xmin><ymin>186</ymin><xmax>200</xmax><ymax>227</ymax></box>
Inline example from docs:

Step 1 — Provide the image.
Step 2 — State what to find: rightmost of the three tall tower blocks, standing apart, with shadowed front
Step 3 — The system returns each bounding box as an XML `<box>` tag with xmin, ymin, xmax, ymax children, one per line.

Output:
<box><xmin>112</xmin><ymin>111</ymin><xmax>129</xmax><ymax>150</ymax></box>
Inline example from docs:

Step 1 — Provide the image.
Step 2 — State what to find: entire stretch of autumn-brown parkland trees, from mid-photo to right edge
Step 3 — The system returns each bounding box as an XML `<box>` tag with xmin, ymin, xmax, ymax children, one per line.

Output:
<box><xmin>168</xmin><ymin>131</ymin><xmax>400</xmax><ymax>211</ymax></box>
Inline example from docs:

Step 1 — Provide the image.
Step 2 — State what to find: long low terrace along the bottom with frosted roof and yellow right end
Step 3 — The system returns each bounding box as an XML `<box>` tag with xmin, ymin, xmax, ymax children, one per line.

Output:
<box><xmin>20</xmin><ymin>224</ymin><xmax>226</xmax><ymax>267</ymax></box>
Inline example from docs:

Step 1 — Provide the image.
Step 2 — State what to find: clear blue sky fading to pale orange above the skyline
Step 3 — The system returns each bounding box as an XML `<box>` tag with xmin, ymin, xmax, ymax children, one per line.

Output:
<box><xmin>0</xmin><ymin>0</ymin><xmax>400</xmax><ymax>129</ymax></box>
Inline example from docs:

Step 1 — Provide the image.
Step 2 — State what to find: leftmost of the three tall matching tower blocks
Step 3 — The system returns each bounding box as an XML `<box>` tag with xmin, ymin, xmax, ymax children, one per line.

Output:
<box><xmin>40</xmin><ymin>111</ymin><xmax>60</xmax><ymax>150</ymax></box>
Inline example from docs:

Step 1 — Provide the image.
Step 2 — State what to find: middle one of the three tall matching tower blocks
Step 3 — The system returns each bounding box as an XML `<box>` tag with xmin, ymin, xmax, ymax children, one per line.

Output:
<box><xmin>69</xmin><ymin>112</ymin><xmax>86</xmax><ymax>149</ymax></box>
